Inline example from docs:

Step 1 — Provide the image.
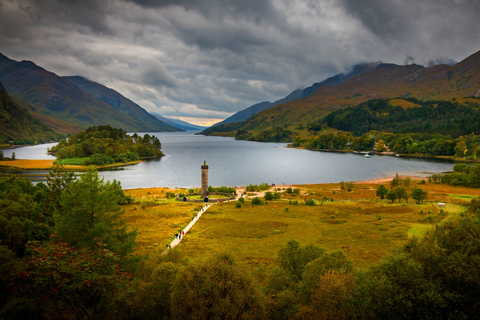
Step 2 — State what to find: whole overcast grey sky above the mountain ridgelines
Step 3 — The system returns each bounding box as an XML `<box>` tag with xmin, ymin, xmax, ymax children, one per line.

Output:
<box><xmin>0</xmin><ymin>0</ymin><xmax>480</xmax><ymax>126</ymax></box>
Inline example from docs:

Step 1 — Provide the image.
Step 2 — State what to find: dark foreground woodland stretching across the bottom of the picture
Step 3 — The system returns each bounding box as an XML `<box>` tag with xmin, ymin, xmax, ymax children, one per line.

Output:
<box><xmin>0</xmin><ymin>167</ymin><xmax>480</xmax><ymax>319</ymax></box>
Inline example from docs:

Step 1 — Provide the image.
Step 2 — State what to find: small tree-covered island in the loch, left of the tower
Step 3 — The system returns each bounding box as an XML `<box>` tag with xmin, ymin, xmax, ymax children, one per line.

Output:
<box><xmin>49</xmin><ymin>125</ymin><xmax>163</xmax><ymax>166</ymax></box>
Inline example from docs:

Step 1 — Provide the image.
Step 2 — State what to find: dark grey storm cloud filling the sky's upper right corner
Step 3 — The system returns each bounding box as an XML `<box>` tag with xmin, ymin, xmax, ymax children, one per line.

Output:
<box><xmin>341</xmin><ymin>0</ymin><xmax>480</xmax><ymax>57</ymax></box>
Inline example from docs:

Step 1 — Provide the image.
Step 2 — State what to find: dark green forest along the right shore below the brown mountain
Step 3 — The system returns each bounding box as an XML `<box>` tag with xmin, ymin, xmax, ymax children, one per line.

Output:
<box><xmin>291</xmin><ymin>99</ymin><xmax>480</xmax><ymax>160</ymax></box>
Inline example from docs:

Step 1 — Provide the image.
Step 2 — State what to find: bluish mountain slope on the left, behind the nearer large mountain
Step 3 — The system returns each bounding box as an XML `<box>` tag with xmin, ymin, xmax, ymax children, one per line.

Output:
<box><xmin>64</xmin><ymin>76</ymin><xmax>178</xmax><ymax>131</ymax></box>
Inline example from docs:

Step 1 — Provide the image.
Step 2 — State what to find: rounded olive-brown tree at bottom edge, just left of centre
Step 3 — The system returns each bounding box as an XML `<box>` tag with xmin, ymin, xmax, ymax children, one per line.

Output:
<box><xmin>171</xmin><ymin>253</ymin><xmax>265</xmax><ymax>319</ymax></box>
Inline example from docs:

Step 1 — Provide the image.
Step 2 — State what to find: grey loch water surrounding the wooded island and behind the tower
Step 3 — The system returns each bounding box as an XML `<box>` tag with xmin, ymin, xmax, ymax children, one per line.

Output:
<box><xmin>0</xmin><ymin>132</ymin><xmax>454</xmax><ymax>189</ymax></box>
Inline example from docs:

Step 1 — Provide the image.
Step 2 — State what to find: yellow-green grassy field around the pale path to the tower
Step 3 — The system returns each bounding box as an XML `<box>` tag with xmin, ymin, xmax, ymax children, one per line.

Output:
<box><xmin>125</xmin><ymin>181</ymin><xmax>480</xmax><ymax>268</ymax></box>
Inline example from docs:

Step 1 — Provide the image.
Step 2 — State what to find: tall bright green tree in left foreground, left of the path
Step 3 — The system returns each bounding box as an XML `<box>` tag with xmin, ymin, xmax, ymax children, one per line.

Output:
<box><xmin>54</xmin><ymin>167</ymin><xmax>136</xmax><ymax>256</ymax></box>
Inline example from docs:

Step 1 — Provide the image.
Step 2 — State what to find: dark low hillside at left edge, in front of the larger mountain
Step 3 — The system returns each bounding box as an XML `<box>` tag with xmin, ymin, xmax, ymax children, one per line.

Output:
<box><xmin>0</xmin><ymin>83</ymin><xmax>64</xmax><ymax>145</ymax></box>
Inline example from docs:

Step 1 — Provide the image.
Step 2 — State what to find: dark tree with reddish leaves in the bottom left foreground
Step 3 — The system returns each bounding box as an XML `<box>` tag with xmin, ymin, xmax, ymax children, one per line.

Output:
<box><xmin>12</xmin><ymin>241</ymin><xmax>133</xmax><ymax>319</ymax></box>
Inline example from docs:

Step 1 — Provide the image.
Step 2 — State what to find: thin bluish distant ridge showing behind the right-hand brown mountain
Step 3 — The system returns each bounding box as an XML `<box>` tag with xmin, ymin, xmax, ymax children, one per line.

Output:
<box><xmin>212</xmin><ymin>62</ymin><xmax>380</xmax><ymax>130</ymax></box>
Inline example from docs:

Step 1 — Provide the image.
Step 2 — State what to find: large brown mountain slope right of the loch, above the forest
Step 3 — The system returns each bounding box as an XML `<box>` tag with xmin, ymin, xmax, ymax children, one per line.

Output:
<box><xmin>203</xmin><ymin>51</ymin><xmax>480</xmax><ymax>137</ymax></box>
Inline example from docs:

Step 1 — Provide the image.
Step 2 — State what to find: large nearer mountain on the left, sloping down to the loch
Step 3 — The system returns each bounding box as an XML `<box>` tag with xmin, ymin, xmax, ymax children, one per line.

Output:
<box><xmin>0</xmin><ymin>55</ymin><xmax>177</xmax><ymax>131</ymax></box>
